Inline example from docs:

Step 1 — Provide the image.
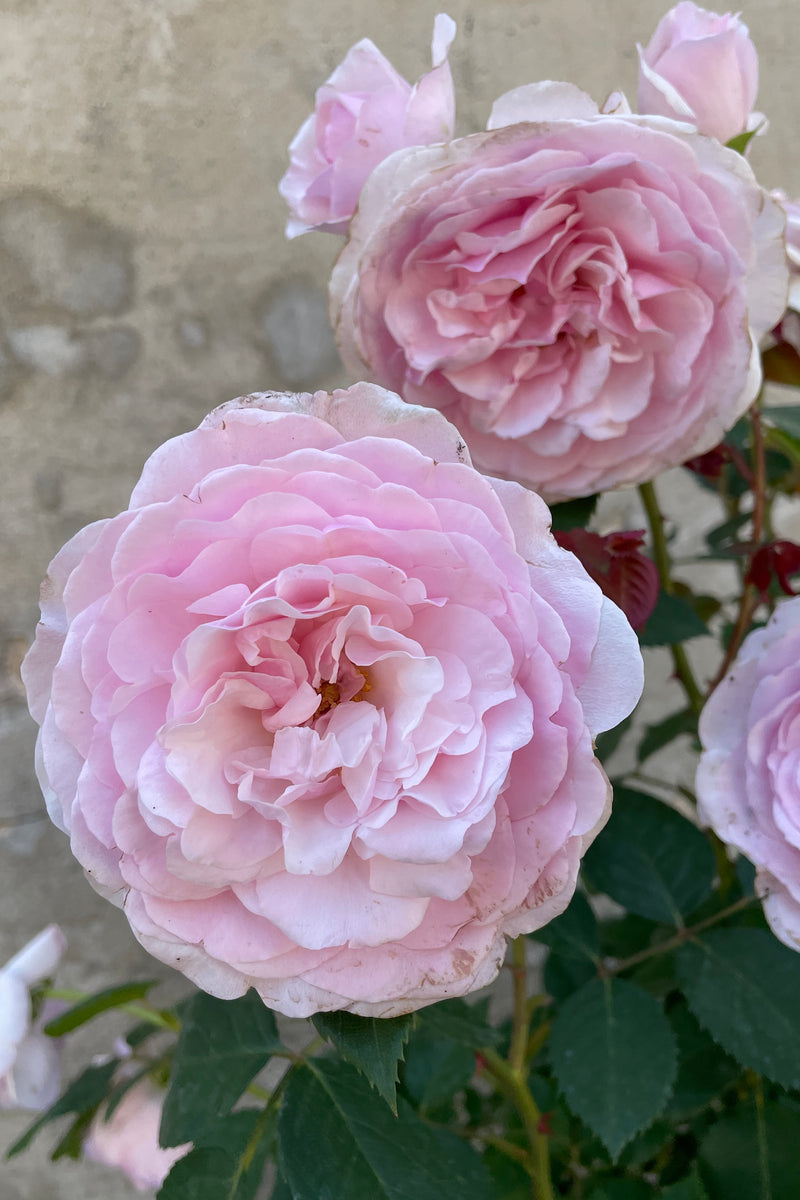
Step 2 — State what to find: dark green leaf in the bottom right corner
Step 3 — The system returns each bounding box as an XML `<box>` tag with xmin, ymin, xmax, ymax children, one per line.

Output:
<box><xmin>692</xmin><ymin>1102</ymin><xmax>800</xmax><ymax>1200</ymax></box>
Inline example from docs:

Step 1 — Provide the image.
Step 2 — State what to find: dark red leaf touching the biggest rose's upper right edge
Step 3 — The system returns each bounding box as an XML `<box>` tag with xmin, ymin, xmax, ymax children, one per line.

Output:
<box><xmin>554</xmin><ymin>528</ymin><xmax>658</xmax><ymax>629</ymax></box>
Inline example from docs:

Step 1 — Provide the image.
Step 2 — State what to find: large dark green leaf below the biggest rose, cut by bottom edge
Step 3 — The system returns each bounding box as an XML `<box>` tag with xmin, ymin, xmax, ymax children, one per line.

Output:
<box><xmin>278</xmin><ymin>1058</ymin><xmax>498</xmax><ymax>1200</ymax></box>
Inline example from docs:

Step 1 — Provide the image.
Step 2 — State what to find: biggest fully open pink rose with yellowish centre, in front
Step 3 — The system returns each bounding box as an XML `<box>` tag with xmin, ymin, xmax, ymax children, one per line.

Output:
<box><xmin>24</xmin><ymin>384</ymin><xmax>642</xmax><ymax>1016</ymax></box>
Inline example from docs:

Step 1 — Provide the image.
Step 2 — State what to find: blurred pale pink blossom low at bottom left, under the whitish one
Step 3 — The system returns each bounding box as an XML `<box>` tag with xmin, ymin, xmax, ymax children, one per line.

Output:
<box><xmin>83</xmin><ymin>1080</ymin><xmax>192</xmax><ymax>1192</ymax></box>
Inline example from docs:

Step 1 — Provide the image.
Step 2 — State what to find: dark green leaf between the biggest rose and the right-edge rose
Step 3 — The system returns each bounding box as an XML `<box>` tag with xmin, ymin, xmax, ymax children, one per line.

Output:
<box><xmin>583</xmin><ymin>787</ymin><xmax>716</xmax><ymax>925</ymax></box>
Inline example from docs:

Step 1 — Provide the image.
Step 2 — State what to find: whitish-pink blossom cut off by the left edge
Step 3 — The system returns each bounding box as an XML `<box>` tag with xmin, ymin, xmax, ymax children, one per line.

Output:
<box><xmin>0</xmin><ymin>925</ymin><xmax>66</xmax><ymax>1111</ymax></box>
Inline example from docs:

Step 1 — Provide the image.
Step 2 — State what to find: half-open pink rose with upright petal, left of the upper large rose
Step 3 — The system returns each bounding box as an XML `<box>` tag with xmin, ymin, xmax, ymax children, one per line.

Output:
<box><xmin>278</xmin><ymin>13</ymin><xmax>456</xmax><ymax>238</ymax></box>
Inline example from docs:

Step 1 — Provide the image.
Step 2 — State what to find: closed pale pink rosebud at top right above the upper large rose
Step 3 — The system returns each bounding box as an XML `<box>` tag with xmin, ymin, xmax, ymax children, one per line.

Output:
<box><xmin>638</xmin><ymin>0</ymin><xmax>764</xmax><ymax>142</ymax></box>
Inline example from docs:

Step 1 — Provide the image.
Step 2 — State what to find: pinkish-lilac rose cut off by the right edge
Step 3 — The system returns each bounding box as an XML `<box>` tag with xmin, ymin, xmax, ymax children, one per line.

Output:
<box><xmin>697</xmin><ymin>598</ymin><xmax>800</xmax><ymax>950</ymax></box>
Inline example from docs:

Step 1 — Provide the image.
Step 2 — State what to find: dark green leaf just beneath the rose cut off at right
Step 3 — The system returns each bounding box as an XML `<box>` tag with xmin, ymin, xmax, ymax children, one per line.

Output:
<box><xmin>678</xmin><ymin>928</ymin><xmax>800</xmax><ymax>1087</ymax></box>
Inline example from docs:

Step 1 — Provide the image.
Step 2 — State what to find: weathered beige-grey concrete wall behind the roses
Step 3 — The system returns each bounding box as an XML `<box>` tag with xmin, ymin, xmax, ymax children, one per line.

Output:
<box><xmin>0</xmin><ymin>0</ymin><xmax>800</xmax><ymax>1200</ymax></box>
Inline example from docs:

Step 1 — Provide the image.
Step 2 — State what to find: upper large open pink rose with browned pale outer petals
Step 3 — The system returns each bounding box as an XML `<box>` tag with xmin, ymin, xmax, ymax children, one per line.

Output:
<box><xmin>331</xmin><ymin>84</ymin><xmax>787</xmax><ymax>500</ymax></box>
